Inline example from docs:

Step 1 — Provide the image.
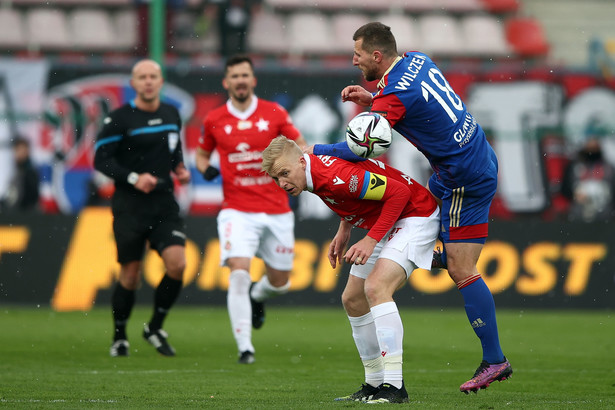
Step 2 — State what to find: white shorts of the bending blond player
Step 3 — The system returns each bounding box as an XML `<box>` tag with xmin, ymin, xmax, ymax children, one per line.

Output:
<box><xmin>350</xmin><ymin>208</ymin><xmax>440</xmax><ymax>279</ymax></box>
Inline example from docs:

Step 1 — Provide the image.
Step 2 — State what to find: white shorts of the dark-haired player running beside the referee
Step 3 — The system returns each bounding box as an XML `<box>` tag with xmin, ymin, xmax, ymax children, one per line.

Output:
<box><xmin>217</xmin><ymin>209</ymin><xmax>295</xmax><ymax>271</ymax></box>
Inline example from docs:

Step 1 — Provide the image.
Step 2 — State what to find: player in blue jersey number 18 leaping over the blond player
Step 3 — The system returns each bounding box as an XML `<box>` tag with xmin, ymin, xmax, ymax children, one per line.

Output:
<box><xmin>310</xmin><ymin>22</ymin><xmax>512</xmax><ymax>393</ymax></box>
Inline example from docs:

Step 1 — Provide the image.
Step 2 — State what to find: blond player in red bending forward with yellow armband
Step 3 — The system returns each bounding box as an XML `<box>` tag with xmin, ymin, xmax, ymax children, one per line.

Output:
<box><xmin>262</xmin><ymin>137</ymin><xmax>440</xmax><ymax>403</ymax></box>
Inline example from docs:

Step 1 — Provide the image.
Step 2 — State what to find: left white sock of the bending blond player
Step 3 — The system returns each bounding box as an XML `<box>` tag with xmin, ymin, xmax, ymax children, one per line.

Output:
<box><xmin>348</xmin><ymin>312</ymin><xmax>384</xmax><ymax>387</ymax></box>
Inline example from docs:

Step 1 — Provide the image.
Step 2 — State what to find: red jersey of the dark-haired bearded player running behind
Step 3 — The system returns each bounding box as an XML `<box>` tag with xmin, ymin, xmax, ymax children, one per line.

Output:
<box><xmin>199</xmin><ymin>96</ymin><xmax>301</xmax><ymax>214</ymax></box>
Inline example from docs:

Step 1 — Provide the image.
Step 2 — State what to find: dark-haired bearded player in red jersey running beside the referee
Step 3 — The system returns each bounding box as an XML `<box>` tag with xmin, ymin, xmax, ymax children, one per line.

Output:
<box><xmin>196</xmin><ymin>55</ymin><xmax>305</xmax><ymax>364</ymax></box>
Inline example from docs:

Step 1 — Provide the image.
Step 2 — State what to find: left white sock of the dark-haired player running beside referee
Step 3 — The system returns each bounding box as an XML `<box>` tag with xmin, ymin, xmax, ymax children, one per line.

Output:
<box><xmin>226</xmin><ymin>269</ymin><xmax>254</xmax><ymax>352</ymax></box>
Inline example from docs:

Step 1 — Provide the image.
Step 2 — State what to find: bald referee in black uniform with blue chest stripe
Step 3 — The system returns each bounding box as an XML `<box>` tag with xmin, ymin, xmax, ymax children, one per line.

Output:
<box><xmin>94</xmin><ymin>60</ymin><xmax>190</xmax><ymax>357</ymax></box>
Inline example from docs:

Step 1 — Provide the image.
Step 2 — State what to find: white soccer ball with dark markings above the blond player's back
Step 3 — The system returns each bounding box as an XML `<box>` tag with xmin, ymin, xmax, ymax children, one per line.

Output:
<box><xmin>346</xmin><ymin>112</ymin><xmax>393</xmax><ymax>158</ymax></box>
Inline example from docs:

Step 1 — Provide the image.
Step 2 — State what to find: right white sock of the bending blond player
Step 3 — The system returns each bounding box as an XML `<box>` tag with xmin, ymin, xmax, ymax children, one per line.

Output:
<box><xmin>371</xmin><ymin>302</ymin><xmax>404</xmax><ymax>389</ymax></box>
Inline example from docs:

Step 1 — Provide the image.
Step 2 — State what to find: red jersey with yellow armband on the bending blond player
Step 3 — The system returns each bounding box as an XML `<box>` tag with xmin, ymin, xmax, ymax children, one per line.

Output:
<box><xmin>304</xmin><ymin>155</ymin><xmax>438</xmax><ymax>241</ymax></box>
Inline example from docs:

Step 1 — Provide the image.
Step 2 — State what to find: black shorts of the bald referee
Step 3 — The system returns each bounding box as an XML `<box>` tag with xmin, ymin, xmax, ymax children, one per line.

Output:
<box><xmin>111</xmin><ymin>191</ymin><xmax>186</xmax><ymax>264</ymax></box>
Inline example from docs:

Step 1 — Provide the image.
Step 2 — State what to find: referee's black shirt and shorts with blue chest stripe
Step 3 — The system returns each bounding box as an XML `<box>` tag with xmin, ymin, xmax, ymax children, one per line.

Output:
<box><xmin>94</xmin><ymin>102</ymin><xmax>185</xmax><ymax>264</ymax></box>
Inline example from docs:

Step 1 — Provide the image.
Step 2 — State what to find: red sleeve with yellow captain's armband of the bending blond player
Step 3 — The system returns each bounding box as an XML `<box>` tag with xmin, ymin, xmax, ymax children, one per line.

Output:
<box><xmin>359</xmin><ymin>171</ymin><xmax>411</xmax><ymax>241</ymax></box>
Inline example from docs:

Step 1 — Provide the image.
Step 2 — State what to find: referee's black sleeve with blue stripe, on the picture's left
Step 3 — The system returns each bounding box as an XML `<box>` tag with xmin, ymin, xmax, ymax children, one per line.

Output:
<box><xmin>94</xmin><ymin>111</ymin><xmax>130</xmax><ymax>181</ymax></box>
